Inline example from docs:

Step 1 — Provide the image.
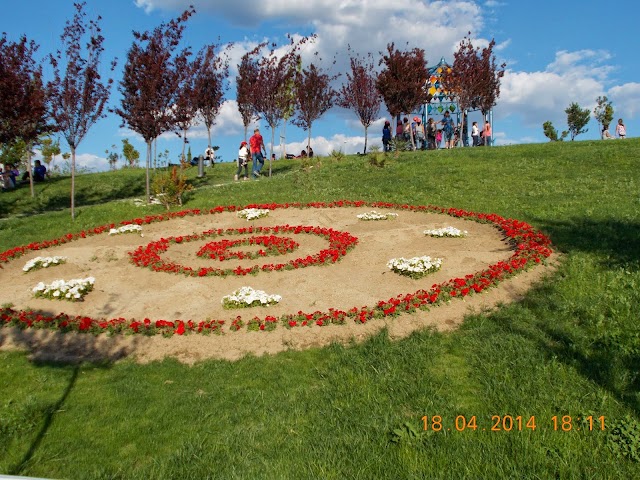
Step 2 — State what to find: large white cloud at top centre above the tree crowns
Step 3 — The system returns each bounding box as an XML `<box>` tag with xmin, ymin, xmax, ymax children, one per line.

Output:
<box><xmin>136</xmin><ymin>0</ymin><xmax>482</xmax><ymax>71</ymax></box>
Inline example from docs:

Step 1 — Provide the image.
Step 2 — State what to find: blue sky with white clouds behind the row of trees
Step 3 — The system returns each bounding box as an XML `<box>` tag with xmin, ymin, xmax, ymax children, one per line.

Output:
<box><xmin>0</xmin><ymin>0</ymin><xmax>640</xmax><ymax>171</ymax></box>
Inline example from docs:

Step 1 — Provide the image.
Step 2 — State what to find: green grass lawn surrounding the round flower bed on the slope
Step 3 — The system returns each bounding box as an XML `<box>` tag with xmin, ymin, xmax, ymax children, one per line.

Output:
<box><xmin>0</xmin><ymin>139</ymin><xmax>640</xmax><ymax>479</ymax></box>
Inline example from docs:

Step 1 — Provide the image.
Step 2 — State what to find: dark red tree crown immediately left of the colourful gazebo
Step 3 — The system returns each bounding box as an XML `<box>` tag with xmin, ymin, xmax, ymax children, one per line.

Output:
<box><xmin>376</xmin><ymin>43</ymin><xmax>428</xmax><ymax>143</ymax></box>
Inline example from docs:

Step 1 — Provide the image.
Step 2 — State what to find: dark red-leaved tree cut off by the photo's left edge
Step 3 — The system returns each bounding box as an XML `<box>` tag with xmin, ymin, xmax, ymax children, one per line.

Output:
<box><xmin>0</xmin><ymin>34</ymin><xmax>53</xmax><ymax>197</ymax></box>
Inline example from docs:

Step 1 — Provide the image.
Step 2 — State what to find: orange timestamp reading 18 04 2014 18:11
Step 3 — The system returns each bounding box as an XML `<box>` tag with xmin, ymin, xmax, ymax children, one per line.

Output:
<box><xmin>421</xmin><ymin>415</ymin><xmax>605</xmax><ymax>432</ymax></box>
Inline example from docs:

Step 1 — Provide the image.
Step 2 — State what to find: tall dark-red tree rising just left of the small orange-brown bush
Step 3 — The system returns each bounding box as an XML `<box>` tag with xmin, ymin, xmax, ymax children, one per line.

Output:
<box><xmin>114</xmin><ymin>7</ymin><xmax>195</xmax><ymax>201</ymax></box>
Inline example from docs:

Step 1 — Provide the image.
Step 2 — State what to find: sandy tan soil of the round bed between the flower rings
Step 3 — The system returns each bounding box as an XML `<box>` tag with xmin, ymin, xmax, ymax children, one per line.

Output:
<box><xmin>0</xmin><ymin>208</ymin><xmax>553</xmax><ymax>363</ymax></box>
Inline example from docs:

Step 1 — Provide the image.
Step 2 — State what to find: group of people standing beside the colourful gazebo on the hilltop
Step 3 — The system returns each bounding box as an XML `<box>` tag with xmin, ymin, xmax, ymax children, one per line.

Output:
<box><xmin>382</xmin><ymin>111</ymin><xmax>492</xmax><ymax>152</ymax></box>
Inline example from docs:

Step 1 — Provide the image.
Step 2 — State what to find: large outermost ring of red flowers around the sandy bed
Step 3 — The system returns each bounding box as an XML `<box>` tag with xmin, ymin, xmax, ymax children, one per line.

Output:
<box><xmin>0</xmin><ymin>200</ymin><xmax>553</xmax><ymax>335</ymax></box>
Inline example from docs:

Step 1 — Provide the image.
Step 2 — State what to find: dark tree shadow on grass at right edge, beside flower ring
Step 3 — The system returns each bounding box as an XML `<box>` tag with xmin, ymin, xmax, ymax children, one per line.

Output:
<box><xmin>535</xmin><ymin>217</ymin><xmax>640</xmax><ymax>269</ymax></box>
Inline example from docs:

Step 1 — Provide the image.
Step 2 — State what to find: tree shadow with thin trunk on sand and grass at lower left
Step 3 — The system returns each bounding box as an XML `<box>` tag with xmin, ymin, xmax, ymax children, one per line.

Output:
<box><xmin>0</xmin><ymin>328</ymin><xmax>136</xmax><ymax>475</ymax></box>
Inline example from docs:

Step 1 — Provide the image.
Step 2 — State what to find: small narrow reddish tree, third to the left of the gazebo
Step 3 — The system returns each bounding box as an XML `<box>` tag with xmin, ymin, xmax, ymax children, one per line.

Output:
<box><xmin>293</xmin><ymin>59</ymin><xmax>337</xmax><ymax>151</ymax></box>
